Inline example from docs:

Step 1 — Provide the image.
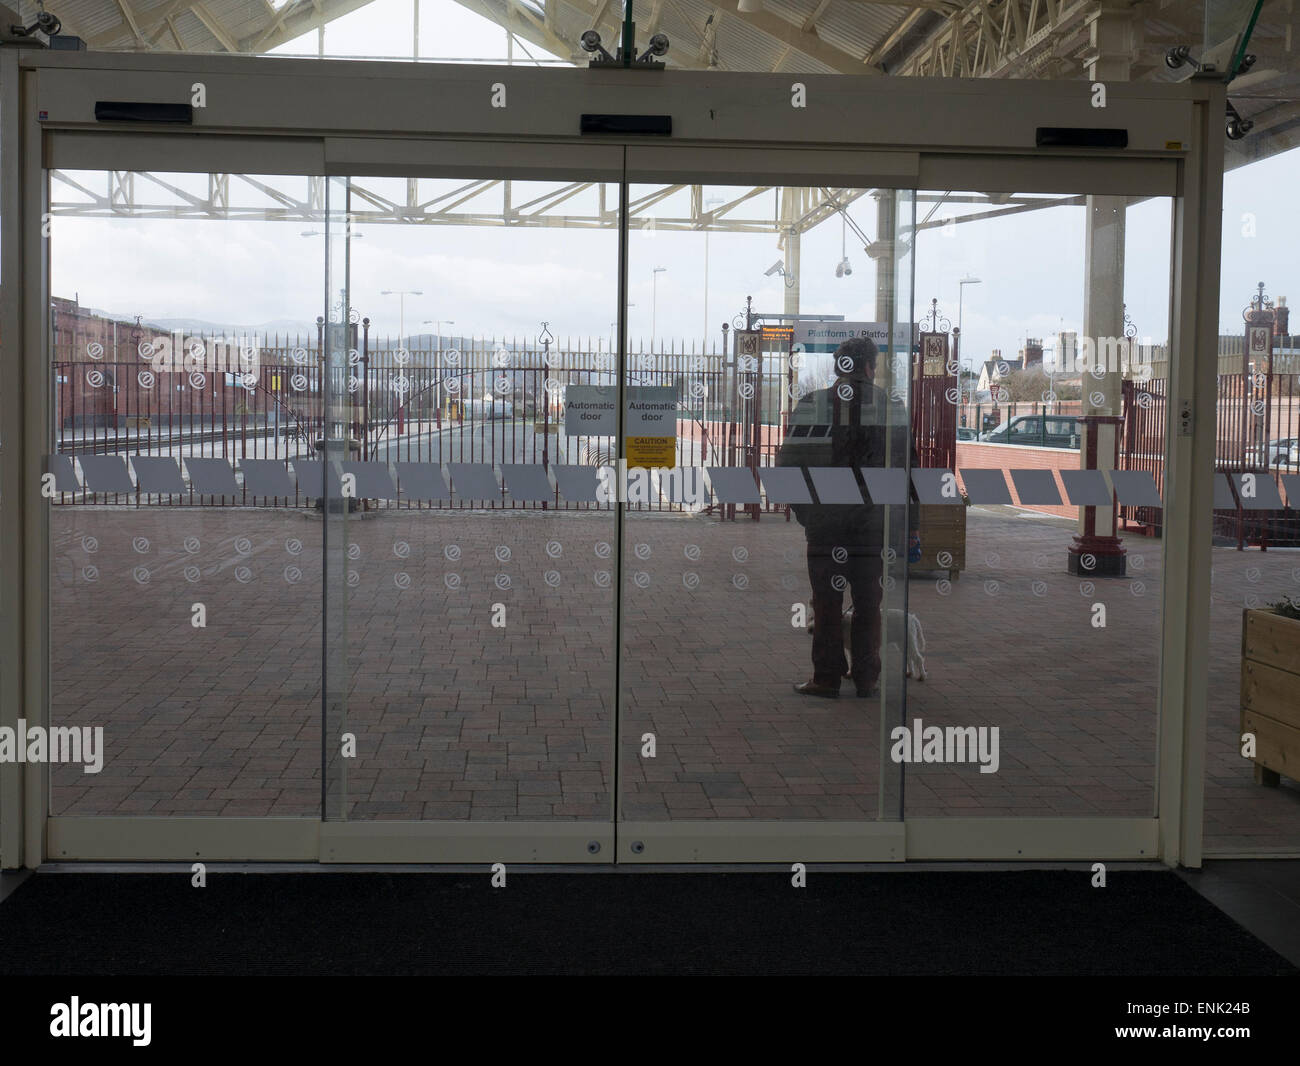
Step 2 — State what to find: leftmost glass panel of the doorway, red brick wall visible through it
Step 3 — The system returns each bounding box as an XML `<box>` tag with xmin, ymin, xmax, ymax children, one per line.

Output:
<box><xmin>47</xmin><ymin>172</ymin><xmax>324</xmax><ymax>818</ymax></box>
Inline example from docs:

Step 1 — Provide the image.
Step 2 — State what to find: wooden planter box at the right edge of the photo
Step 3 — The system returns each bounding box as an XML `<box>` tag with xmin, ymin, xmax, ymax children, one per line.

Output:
<box><xmin>1242</xmin><ymin>611</ymin><xmax>1300</xmax><ymax>785</ymax></box>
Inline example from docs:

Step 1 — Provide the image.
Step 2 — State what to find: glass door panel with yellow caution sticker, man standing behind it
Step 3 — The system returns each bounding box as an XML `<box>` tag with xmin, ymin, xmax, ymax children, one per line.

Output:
<box><xmin>620</xmin><ymin>185</ymin><xmax>915</xmax><ymax>826</ymax></box>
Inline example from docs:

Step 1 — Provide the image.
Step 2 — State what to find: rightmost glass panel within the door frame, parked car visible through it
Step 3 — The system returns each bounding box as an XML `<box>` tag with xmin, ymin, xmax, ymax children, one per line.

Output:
<box><xmin>906</xmin><ymin>190</ymin><xmax>1171</xmax><ymax>818</ymax></box>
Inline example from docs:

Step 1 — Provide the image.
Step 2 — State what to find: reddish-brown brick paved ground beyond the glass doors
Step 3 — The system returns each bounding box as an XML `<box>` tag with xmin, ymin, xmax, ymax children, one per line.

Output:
<box><xmin>52</xmin><ymin>507</ymin><xmax>1300</xmax><ymax>852</ymax></box>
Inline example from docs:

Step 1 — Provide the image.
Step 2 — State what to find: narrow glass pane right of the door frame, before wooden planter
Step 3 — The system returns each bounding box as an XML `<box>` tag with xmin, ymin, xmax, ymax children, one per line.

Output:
<box><xmin>1205</xmin><ymin>150</ymin><xmax>1300</xmax><ymax>855</ymax></box>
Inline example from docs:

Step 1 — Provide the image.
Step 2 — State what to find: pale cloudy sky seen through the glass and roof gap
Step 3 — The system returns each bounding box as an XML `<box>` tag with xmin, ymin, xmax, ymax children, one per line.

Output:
<box><xmin>51</xmin><ymin>0</ymin><xmax>1300</xmax><ymax>360</ymax></box>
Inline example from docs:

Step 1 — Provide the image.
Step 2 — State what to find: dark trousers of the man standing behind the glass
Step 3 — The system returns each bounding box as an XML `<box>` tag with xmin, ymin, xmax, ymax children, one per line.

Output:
<box><xmin>809</xmin><ymin>543</ymin><xmax>884</xmax><ymax>689</ymax></box>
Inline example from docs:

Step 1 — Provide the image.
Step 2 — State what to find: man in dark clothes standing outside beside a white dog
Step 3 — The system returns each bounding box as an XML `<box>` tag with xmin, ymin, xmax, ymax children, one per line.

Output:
<box><xmin>776</xmin><ymin>337</ymin><xmax>920</xmax><ymax>698</ymax></box>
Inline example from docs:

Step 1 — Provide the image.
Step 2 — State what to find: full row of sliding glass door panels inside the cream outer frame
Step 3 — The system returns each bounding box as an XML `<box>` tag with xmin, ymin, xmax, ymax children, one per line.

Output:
<box><xmin>47</xmin><ymin>122</ymin><xmax>1196</xmax><ymax>863</ymax></box>
